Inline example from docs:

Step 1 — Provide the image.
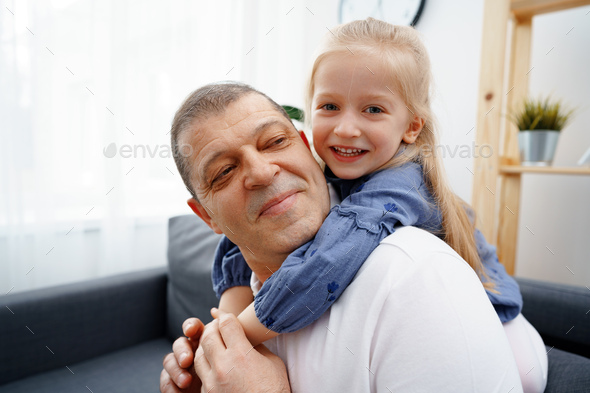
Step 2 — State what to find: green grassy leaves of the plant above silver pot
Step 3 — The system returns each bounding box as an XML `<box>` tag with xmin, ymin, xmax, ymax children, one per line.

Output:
<box><xmin>510</xmin><ymin>97</ymin><xmax>574</xmax><ymax>131</ymax></box>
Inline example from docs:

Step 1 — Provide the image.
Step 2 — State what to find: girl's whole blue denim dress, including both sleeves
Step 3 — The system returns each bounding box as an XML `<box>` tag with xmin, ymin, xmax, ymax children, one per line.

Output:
<box><xmin>212</xmin><ymin>162</ymin><xmax>522</xmax><ymax>333</ymax></box>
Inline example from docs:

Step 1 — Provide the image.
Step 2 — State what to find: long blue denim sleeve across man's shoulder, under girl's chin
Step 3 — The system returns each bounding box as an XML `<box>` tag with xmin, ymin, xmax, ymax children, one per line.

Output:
<box><xmin>254</xmin><ymin>167</ymin><xmax>432</xmax><ymax>333</ymax></box>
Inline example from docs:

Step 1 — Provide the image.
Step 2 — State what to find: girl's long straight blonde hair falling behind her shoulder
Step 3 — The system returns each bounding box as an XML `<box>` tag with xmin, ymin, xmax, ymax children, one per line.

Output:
<box><xmin>305</xmin><ymin>18</ymin><xmax>496</xmax><ymax>292</ymax></box>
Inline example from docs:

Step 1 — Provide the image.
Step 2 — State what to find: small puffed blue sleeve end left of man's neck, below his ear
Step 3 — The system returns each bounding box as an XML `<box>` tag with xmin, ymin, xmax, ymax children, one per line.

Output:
<box><xmin>211</xmin><ymin>236</ymin><xmax>252</xmax><ymax>299</ymax></box>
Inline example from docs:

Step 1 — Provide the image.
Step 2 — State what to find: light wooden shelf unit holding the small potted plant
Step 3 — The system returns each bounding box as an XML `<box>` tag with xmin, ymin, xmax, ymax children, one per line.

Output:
<box><xmin>472</xmin><ymin>0</ymin><xmax>590</xmax><ymax>274</ymax></box>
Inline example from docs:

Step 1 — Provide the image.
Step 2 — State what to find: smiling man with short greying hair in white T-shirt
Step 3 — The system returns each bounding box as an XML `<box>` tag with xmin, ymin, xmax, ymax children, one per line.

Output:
<box><xmin>160</xmin><ymin>84</ymin><xmax>522</xmax><ymax>392</ymax></box>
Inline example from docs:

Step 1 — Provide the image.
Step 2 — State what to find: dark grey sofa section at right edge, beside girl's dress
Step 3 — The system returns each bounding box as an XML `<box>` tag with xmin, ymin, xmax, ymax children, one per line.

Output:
<box><xmin>516</xmin><ymin>278</ymin><xmax>590</xmax><ymax>358</ymax></box>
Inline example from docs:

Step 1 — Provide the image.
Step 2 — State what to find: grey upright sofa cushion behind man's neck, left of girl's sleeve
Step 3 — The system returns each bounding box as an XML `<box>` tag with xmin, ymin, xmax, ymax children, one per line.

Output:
<box><xmin>167</xmin><ymin>214</ymin><xmax>221</xmax><ymax>340</ymax></box>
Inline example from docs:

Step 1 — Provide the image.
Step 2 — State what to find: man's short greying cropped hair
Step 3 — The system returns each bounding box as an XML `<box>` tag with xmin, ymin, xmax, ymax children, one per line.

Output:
<box><xmin>170</xmin><ymin>82</ymin><xmax>291</xmax><ymax>200</ymax></box>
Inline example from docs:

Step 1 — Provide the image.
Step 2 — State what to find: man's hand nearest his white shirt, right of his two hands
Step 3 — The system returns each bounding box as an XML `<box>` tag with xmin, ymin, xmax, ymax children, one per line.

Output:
<box><xmin>195</xmin><ymin>314</ymin><xmax>291</xmax><ymax>393</ymax></box>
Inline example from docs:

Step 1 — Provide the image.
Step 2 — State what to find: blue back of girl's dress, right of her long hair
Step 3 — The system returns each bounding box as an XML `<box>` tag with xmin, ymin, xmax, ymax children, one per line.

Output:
<box><xmin>474</xmin><ymin>229</ymin><xmax>522</xmax><ymax>323</ymax></box>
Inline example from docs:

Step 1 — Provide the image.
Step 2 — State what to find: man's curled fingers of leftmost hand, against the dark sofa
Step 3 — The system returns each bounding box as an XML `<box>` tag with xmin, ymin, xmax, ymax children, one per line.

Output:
<box><xmin>160</xmin><ymin>318</ymin><xmax>205</xmax><ymax>393</ymax></box>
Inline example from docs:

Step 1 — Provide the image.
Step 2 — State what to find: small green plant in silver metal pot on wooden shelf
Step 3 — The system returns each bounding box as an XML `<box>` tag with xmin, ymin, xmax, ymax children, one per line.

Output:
<box><xmin>511</xmin><ymin>98</ymin><xmax>573</xmax><ymax>166</ymax></box>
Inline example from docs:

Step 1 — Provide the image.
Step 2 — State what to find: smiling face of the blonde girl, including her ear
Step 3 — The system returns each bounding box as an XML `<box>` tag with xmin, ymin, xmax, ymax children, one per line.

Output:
<box><xmin>311</xmin><ymin>53</ymin><xmax>423</xmax><ymax>179</ymax></box>
